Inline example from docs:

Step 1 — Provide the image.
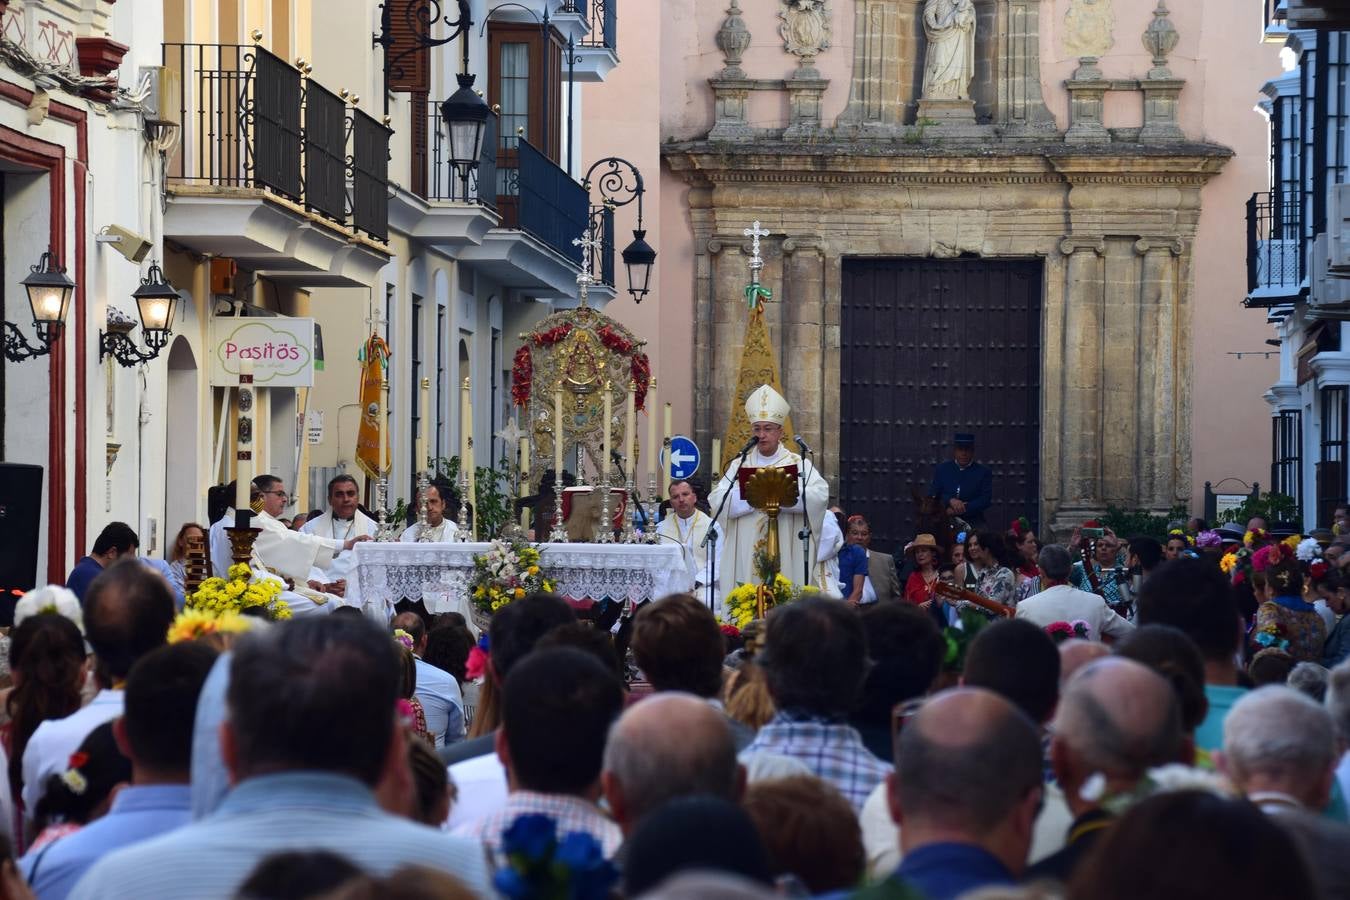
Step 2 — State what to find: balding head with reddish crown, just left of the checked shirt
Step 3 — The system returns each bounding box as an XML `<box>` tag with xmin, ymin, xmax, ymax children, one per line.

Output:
<box><xmin>601</xmin><ymin>691</ymin><xmax>745</xmax><ymax>835</ymax></box>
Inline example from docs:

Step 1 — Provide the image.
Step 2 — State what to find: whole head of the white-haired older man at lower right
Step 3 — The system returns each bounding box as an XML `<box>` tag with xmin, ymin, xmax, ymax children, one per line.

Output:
<box><xmin>1220</xmin><ymin>685</ymin><xmax>1337</xmax><ymax>810</ymax></box>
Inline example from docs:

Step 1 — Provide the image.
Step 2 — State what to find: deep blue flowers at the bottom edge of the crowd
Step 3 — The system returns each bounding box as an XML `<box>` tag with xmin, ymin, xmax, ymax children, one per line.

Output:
<box><xmin>493</xmin><ymin>814</ymin><xmax>618</xmax><ymax>900</ymax></box>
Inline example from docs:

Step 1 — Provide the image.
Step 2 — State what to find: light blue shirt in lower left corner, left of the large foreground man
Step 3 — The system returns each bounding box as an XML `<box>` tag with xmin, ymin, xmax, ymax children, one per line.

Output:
<box><xmin>19</xmin><ymin>784</ymin><xmax>192</xmax><ymax>900</ymax></box>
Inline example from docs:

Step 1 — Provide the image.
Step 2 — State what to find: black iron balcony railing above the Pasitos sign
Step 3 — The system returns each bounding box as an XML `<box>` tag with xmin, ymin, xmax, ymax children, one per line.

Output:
<box><xmin>163</xmin><ymin>43</ymin><xmax>390</xmax><ymax>240</ymax></box>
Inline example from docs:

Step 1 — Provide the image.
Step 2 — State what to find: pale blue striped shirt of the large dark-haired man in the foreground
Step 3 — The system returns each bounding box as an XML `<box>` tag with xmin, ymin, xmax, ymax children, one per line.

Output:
<box><xmin>70</xmin><ymin>770</ymin><xmax>491</xmax><ymax>900</ymax></box>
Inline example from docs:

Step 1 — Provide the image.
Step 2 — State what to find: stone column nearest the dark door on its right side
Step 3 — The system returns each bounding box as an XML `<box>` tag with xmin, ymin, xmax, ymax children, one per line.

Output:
<box><xmin>1058</xmin><ymin>236</ymin><xmax>1106</xmax><ymax>518</ymax></box>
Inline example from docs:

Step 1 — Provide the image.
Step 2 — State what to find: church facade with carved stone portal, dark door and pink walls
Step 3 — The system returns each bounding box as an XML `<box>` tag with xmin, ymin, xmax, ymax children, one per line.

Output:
<box><xmin>662</xmin><ymin>0</ymin><xmax>1278</xmax><ymax>546</ymax></box>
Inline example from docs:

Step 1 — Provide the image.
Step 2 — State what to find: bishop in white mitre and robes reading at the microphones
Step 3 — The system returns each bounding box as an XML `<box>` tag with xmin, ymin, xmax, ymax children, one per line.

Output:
<box><xmin>707</xmin><ymin>385</ymin><xmax>830</xmax><ymax>591</ymax></box>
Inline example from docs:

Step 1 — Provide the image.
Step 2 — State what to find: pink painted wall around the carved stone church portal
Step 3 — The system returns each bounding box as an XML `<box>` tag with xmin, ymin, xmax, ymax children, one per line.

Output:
<box><xmin>653</xmin><ymin>0</ymin><xmax>1280</xmax><ymax>510</ymax></box>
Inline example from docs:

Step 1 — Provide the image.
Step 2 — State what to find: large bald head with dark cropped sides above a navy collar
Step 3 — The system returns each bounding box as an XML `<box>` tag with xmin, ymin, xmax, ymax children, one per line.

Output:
<box><xmin>888</xmin><ymin>688</ymin><xmax>1042</xmax><ymax>876</ymax></box>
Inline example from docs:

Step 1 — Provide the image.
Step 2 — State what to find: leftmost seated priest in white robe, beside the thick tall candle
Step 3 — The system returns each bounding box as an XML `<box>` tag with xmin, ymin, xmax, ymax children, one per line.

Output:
<box><xmin>251</xmin><ymin>475</ymin><xmax>370</xmax><ymax>611</ymax></box>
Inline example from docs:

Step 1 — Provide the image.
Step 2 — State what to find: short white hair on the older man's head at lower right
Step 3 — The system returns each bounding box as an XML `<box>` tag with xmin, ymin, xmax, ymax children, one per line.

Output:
<box><xmin>1223</xmin><ymin>684</ymin><xmax>1337</xmax><ymax>781</ymax></box>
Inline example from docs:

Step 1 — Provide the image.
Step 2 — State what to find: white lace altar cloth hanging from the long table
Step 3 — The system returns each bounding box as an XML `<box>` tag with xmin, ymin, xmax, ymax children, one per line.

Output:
<box><xmin>354</xmin><ymin>541</ymin><xmax>694</xmax><ymax>618</ymax></box>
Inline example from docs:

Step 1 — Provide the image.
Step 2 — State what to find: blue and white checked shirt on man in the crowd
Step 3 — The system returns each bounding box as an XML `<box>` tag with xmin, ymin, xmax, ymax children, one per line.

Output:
<box><xmin>741</xmin><ymin>712</ymin><xmax>894</xmax><ymax>812</ymax></box>
